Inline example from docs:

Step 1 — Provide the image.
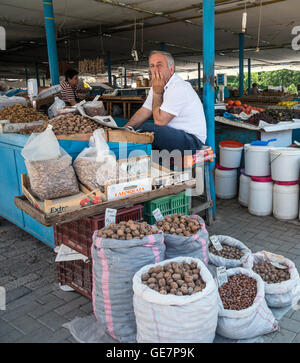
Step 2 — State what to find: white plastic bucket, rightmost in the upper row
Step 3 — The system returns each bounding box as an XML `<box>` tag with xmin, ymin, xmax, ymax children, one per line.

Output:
<box><xmin>270</xmin><ymin>148</ymin><xmax>300</xmax><ymax>182</ymax></box>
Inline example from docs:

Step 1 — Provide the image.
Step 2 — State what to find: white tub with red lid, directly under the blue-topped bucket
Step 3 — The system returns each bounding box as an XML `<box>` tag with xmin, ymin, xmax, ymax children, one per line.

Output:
<box><xmin>248</xmin><ymin>177</ymin><xmax>273</xmax><ymax>216</ymax></box>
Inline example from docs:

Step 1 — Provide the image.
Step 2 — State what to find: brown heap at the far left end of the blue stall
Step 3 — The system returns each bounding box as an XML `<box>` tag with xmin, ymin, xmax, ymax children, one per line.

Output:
<box><xmin>0</xmin><ymin>104</ymin><xmax>48</xmax><ymax>124</ymax></box>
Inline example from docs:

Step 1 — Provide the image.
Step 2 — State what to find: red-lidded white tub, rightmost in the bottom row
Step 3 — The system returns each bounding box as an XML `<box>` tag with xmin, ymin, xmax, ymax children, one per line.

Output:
<box><xmin>273</xmin><ymin>181</ymin><xmax>299</xmax><ymax>220</ymax></box>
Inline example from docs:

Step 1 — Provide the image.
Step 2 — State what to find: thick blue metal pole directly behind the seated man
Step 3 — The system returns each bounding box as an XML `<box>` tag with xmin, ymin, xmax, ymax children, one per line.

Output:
<box><xmin>203</xmin><ymin>0</ymin><xmax>216</xmax><ymax>216</ymax></box>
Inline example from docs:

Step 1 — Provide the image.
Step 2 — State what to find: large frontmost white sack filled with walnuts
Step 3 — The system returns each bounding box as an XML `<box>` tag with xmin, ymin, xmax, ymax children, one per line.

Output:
<box><xmin>133</xmin><ymin>257</ymin><xmax>218</xmax><ymax>343</ymax></box>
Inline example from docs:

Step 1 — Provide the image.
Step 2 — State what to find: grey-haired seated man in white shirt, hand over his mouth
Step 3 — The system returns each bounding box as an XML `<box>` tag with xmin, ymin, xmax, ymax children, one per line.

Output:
<box><xmin>125</xmin><ymin>51</ymin><xmax>206</xmax><ymax>154</ymax></box>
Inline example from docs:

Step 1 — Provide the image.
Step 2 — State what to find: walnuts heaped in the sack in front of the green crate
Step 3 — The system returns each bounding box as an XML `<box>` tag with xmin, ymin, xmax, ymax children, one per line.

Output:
<box><xmin>156</xmin><ymin>213</ymin><xmax>201</xmax><ymax>237</ymax></box>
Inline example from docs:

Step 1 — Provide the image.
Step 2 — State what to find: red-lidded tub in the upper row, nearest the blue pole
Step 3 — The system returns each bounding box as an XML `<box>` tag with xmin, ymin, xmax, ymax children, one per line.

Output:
<box><xmin>219</xmin><ymin>141</ymin><xmax>244</xmax><ymax>168</ymax></box>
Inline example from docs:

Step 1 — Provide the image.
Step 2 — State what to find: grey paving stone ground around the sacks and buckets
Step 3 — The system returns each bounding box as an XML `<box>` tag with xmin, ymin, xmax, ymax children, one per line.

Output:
<box><xmin>0</xmin><ymin>200</ymin><xmax>300</xmax><ymax>343</ymax></box>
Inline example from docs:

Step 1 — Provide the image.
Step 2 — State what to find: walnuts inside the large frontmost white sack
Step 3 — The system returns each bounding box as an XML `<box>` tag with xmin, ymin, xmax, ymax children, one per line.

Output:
<box><xmin>142</xmin><ymin>261</ymin><xmax>206</xmax><ymax>296</ymax></box>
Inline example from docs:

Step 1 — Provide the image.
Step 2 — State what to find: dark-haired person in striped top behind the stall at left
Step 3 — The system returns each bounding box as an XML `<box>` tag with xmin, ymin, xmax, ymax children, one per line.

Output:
<box><xmin>60</xmin><ymin>69</ymin><xmax>88</xmax><ymax>106</ymax></box>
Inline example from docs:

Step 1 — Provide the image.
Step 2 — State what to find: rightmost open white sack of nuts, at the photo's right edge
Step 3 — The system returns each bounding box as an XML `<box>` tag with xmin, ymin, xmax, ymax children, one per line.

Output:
<box><xmin>244</xmin><ymin>251</ymin><xmax>300</xmax><ymax>308</ymax></box>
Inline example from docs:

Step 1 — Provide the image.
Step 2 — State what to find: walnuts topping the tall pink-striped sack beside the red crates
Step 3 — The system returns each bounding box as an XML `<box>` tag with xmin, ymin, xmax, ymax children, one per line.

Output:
<box><xmin>98</xmin><ymin>220</ymin><xmax>158</xmax><ymax>240</ymax></box>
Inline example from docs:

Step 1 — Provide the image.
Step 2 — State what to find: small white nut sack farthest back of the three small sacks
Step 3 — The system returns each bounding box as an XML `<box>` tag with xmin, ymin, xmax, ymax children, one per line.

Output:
<box><xmin>208</xmin><ymin>235</ymin><xmax>252</xmax><ymax>268</ymax></box>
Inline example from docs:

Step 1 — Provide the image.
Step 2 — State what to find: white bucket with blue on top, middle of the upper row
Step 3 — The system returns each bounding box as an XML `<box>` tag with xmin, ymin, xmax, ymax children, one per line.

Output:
<box><xmin>244</xmin><ymin>144</ymin><xmax>273</xmax><ymax>177</ymax></box>
